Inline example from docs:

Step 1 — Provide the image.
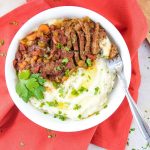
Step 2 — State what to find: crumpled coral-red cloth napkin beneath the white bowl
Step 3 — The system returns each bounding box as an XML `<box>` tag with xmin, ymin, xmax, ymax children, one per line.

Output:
<box><xmin>0</xmin><ymin>0</ymin><xmax>147</xmax><ymax>150</ymax></box>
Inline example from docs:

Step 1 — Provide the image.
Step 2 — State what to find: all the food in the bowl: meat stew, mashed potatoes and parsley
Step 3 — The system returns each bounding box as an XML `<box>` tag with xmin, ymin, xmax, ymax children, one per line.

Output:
<box><xmin>13</xmin><ymin>17</ymin><xmax>118</xmax><ymax>121</ymax></box>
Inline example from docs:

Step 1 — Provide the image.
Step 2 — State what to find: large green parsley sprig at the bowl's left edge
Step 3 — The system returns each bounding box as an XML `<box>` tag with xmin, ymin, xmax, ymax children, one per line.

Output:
<box><xmin>16</xmin><ymin>70</ymin><xmax>45</xmax><ymax>102</ymax></box>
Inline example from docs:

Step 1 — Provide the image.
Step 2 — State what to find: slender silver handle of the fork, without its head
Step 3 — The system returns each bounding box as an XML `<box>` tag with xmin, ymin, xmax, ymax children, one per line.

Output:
<box><xmin>118</xmin><ymin>73</ymin><xmax>150</xmax><ymax>142</ymax></box>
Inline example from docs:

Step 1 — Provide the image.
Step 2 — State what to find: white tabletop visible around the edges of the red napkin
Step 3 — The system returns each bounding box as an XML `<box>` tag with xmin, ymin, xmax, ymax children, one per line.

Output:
<box><xmin>0</xmin><ymin>0</ymin><xmax>150</xmax><ymax>150</ymax></box>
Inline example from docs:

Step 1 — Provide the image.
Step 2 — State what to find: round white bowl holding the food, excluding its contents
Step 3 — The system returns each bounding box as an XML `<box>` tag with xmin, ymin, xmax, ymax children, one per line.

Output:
<box><xmin>5</xmin><ymin>6</ymin><xmax>131</xmax><ymax>132</ymax></box>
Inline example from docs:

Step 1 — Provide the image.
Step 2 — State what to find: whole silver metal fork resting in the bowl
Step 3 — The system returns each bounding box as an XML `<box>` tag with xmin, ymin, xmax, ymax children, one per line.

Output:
<box><xmin>107</xmin><ymin>55</ymin><xmax>150</xmax><ymax>142</ymax></box>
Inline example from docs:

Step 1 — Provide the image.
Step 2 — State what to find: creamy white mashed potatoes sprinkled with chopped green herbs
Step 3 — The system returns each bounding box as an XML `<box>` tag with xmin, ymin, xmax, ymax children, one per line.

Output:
<box><xmin>31</xmin><ymin>58</ymin><xmax>115</xmax><ymax>120</ymax></box>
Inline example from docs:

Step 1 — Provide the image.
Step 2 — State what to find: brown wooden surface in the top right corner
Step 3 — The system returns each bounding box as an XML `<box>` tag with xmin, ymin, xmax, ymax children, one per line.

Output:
<box><xmin>138</xmin><ymin>0</ymin><xmax>150</xmax><ymax>43</ymax></box>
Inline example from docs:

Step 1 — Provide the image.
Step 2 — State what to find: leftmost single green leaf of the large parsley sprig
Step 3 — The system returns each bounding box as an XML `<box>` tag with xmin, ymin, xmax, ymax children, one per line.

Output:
<box><xmin>16</xmin><ymin>82</ymin><xmax>30</xmax><ymax>103</ymax></box>
